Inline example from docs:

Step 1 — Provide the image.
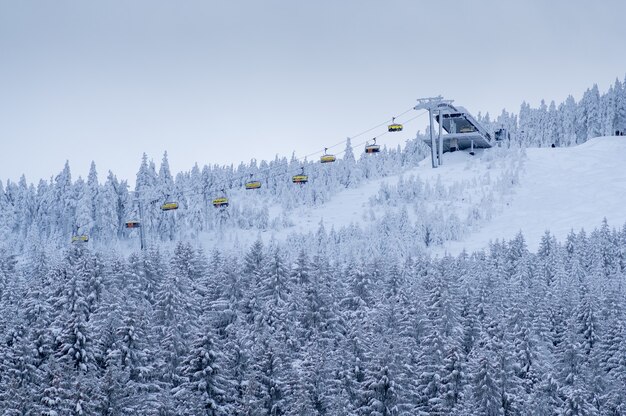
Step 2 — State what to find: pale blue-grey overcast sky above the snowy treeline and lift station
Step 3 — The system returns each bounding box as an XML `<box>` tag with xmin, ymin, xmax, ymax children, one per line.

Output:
<box><xmin>0</xmin><ymin>0</ymin><xmax>626</xmax><ymax>183</ymax></box>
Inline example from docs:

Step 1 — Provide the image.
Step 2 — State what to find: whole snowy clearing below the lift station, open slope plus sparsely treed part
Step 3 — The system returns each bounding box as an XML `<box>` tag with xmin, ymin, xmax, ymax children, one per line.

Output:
<box><xmin>222</xmin><ymin>137</ymin><xmax>626</xmax><ymax>255</ymax></box>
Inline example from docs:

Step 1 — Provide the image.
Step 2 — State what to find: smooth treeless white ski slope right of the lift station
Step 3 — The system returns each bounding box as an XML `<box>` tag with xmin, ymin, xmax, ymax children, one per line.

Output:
<box><xmin>444</xmin><ymin>136</ymin><xmax>626</xmax><ymax>254</ymax></box>
